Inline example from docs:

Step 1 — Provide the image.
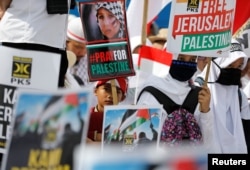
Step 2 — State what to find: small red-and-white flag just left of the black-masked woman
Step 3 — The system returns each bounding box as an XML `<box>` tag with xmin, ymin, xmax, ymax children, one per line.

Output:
<box><xmin>138</xmin><ymin>46</ymin><xmax>172</xmax><ymax>77</ymax></box>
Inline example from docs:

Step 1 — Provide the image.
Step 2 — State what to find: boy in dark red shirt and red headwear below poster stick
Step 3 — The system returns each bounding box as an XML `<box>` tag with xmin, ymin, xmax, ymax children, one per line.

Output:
<box><xmin>88</xmin><ymin>78</ymin><xmax>128</xmax><ymax>142</ymax></box>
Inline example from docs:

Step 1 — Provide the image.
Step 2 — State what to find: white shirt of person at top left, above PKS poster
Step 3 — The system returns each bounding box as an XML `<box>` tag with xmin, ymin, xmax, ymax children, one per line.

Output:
<box><xmin>0</xmin><ymin>0</ymin><xmax>68</xmax><ymax>48</ymax></box>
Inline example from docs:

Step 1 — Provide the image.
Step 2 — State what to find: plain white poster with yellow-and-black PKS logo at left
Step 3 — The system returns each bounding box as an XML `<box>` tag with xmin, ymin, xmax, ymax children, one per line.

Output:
<box><xmin>0</xmin><ymin>45</ymin><xmax>61</xmax><ymax>90</ymax></box>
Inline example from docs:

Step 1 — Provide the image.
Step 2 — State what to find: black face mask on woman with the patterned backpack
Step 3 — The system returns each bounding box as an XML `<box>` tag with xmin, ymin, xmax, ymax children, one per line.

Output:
<box><xmin>169</xmin><ymin>60</ymin><xmax>197</xmax><ymax>81</ymax></box>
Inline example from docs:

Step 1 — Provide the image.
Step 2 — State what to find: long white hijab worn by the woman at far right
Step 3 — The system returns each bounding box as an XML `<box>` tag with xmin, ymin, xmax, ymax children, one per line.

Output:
<box><xmin>198</xmin><ymin>40</ymin><xmax>247</xmax><ymax>153</ymax></box>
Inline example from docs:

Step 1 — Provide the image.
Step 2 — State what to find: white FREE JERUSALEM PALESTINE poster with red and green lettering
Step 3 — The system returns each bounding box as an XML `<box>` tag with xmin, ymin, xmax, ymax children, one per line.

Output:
<box><xmin>167</xmin><ymin>0</ymin><xmax>236</xmax><ymax>57</ymax></box>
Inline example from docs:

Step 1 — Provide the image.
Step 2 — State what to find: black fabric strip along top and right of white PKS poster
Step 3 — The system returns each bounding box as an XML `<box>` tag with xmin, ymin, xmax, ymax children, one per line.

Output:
<box><xmin>2</xmin><ymin>42</ymin><xmax>68</xmax><ymax>87</ymax></box>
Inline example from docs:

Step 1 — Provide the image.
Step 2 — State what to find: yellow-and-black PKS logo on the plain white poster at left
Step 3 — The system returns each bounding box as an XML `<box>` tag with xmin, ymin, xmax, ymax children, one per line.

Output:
<box><xmin>11</xmin><ymin>56</ymin><xmax>32</xmax><ymax>85</ymax></box>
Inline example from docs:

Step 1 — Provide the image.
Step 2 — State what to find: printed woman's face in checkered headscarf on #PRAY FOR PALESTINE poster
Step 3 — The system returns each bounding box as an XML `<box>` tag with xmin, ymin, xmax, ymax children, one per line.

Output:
<box><xmin>95</xmin><ymin>1</ymin><xmax>126</xmax><ymax>40</ymax></box>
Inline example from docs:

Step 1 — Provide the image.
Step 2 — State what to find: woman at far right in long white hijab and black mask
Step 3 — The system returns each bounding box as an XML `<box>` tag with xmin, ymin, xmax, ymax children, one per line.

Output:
<box><xmin>198</xmin><ymin>40</ymin><xmax>249</xmax><ymax>153</ymax></box>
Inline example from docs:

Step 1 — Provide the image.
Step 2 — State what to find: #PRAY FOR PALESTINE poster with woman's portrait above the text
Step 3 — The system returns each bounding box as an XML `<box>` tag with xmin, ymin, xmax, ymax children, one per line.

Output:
<box><xmin>79</xmin><ymin>0</ymin><xmax>135</xmax><ymax>81</ymax></box>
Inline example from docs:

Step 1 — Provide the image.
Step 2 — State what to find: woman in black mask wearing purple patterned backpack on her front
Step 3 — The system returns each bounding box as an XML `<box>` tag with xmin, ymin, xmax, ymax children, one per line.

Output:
<box><xmin>137</xmin><ymin>54</ymin><xmax>213</xmax><ymax>149</ymax></box>
